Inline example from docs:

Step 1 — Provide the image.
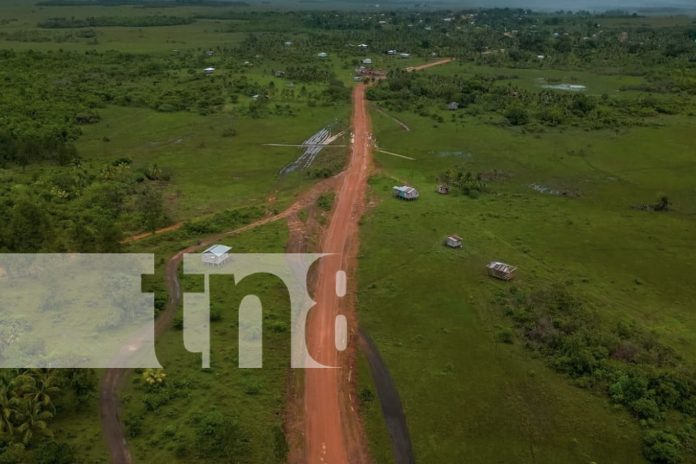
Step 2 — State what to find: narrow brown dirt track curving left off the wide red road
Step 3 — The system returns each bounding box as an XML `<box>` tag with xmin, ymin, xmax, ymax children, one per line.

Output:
<box><xmin>99</xmin><ymin>174</ymin><xmax>342</xmax><ymax>464</ymax></box>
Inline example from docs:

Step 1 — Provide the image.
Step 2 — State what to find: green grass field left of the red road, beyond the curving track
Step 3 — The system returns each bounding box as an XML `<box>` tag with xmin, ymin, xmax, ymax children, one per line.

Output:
<box><xmin>79</xmin><ymin>107</ymin><xmax>347</xmax><ymax>220</ymax></box>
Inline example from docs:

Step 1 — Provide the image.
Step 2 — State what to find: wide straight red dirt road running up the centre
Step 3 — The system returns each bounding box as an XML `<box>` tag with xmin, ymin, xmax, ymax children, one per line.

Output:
<box><xmin>304</xmin><ymin>84</ymin><xmax>371</xmax><ymax>464</ymax></box>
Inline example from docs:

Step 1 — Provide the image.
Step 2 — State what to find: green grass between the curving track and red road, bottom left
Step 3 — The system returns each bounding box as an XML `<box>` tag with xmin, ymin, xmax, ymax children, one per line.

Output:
<box><xmin>121</xmin><ymin>222</ymin><xmax>290</xmax><ymax>463</ymax></box>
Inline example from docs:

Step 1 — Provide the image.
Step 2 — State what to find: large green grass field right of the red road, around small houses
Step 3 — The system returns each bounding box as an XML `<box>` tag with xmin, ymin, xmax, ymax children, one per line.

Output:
<box><xmin>359</xmin><ymin>97</ymin><xmax>696</xmax><ymax>463</ymax></box>
